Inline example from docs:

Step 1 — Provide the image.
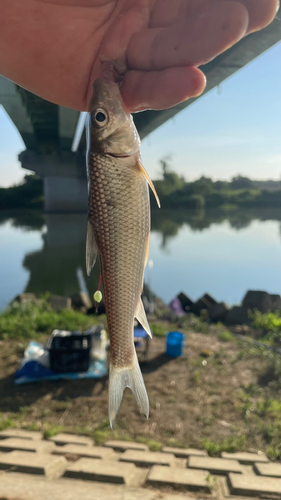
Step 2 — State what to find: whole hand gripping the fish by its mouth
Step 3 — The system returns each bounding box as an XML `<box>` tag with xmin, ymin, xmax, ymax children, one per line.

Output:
<box><xmin>0</xmin><ymin>0</ymin><xmax>278</xmax><ymax>111</ymax></box>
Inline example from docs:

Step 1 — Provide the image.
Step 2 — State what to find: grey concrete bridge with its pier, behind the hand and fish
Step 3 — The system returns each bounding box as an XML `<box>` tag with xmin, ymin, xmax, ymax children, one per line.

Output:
<box><xmin>0</xmin><ymin>9</ymin><xmax>281</xmax><ymax>212</ymax></box>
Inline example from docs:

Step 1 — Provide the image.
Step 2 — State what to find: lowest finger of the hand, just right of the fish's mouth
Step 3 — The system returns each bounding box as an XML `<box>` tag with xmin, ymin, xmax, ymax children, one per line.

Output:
<box><xmin>121</xmin><ymin>67</ymin><xmax>206</xmax><ymax>113</ymax></box>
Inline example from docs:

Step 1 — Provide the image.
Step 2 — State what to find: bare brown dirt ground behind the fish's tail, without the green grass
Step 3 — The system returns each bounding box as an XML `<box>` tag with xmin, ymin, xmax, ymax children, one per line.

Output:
<box><xmin>0</xmin><ymin>332</ymin><xmax>281</xmax><ymax>454</ymax></box>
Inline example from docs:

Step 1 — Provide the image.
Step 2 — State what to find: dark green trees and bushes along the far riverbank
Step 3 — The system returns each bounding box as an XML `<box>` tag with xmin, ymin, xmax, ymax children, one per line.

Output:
<box><xmin>0</xmin><ymin>158</ymin><xmax>281</xmax><ymax>212</ymax></box>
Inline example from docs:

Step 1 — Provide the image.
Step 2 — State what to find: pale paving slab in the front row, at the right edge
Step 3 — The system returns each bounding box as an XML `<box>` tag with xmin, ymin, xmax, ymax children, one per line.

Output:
<box><xmin>228</xmin><ymin>473</ymin><xmax>281</xmax><ymax>497</ymax></box>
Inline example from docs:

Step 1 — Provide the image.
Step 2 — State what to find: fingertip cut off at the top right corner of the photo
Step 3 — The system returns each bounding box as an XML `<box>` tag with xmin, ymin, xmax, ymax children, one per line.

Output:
<box><xmin>227</xmin><ymin>0</ymin><xmax>279</xmax><ymax>33</ymax></box>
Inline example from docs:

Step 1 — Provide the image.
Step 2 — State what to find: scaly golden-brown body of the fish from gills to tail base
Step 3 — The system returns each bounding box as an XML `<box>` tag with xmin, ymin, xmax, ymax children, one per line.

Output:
<box><xmin>89</xmin><ymin>154</ymin><xmax>150</xmax><ymax>367</ymax></box>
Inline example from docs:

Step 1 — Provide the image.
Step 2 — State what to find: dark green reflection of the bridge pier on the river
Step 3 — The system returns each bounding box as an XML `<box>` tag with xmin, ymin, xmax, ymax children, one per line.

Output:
<box><xmin>0</xmin><ymin>212</ymin><xmax>99</xmax><ymax>296</ymax></box>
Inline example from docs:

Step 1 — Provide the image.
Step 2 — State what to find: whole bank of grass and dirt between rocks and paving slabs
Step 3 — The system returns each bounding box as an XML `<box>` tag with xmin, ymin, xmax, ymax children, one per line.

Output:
<box><xmin>0</xmin><ymin>301</ymin><xmax>281</xmax><ymax>459</ymax></box>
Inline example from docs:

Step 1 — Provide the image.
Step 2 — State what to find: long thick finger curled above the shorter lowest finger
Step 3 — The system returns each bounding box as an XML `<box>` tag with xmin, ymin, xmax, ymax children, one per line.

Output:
<box><xmin>127</xmin><ymin>1</ymin><xmax>248</xmax><ymax>71</ymax></box>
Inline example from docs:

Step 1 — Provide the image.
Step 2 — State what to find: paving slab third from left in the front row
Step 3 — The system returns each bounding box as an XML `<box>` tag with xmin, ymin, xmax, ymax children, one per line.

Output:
<box><xmin>146</xmin><ymin>465</ymin><xmax>211</xmax><ymax>493</ymax></box>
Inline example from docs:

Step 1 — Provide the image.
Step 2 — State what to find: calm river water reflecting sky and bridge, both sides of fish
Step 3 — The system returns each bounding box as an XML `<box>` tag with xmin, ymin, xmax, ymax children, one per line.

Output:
<box><xmin>0</xmin><ymin>209</ymin><xmax>281</xmax><ymax>310</ymax></box>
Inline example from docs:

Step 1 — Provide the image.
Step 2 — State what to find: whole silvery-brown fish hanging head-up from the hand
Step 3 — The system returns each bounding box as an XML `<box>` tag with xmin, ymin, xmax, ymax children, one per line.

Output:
<box><xmin>86</xmin><ymin>76</ymin><xmax>160</xmax><ymax>427</ymax></box>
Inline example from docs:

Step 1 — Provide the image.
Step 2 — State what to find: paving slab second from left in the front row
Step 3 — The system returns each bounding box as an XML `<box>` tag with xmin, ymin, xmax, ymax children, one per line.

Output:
<box><xmin>64</xmin><ymin>458</ymin><xmax>137</xmax><ymax>484</ymax></box>
